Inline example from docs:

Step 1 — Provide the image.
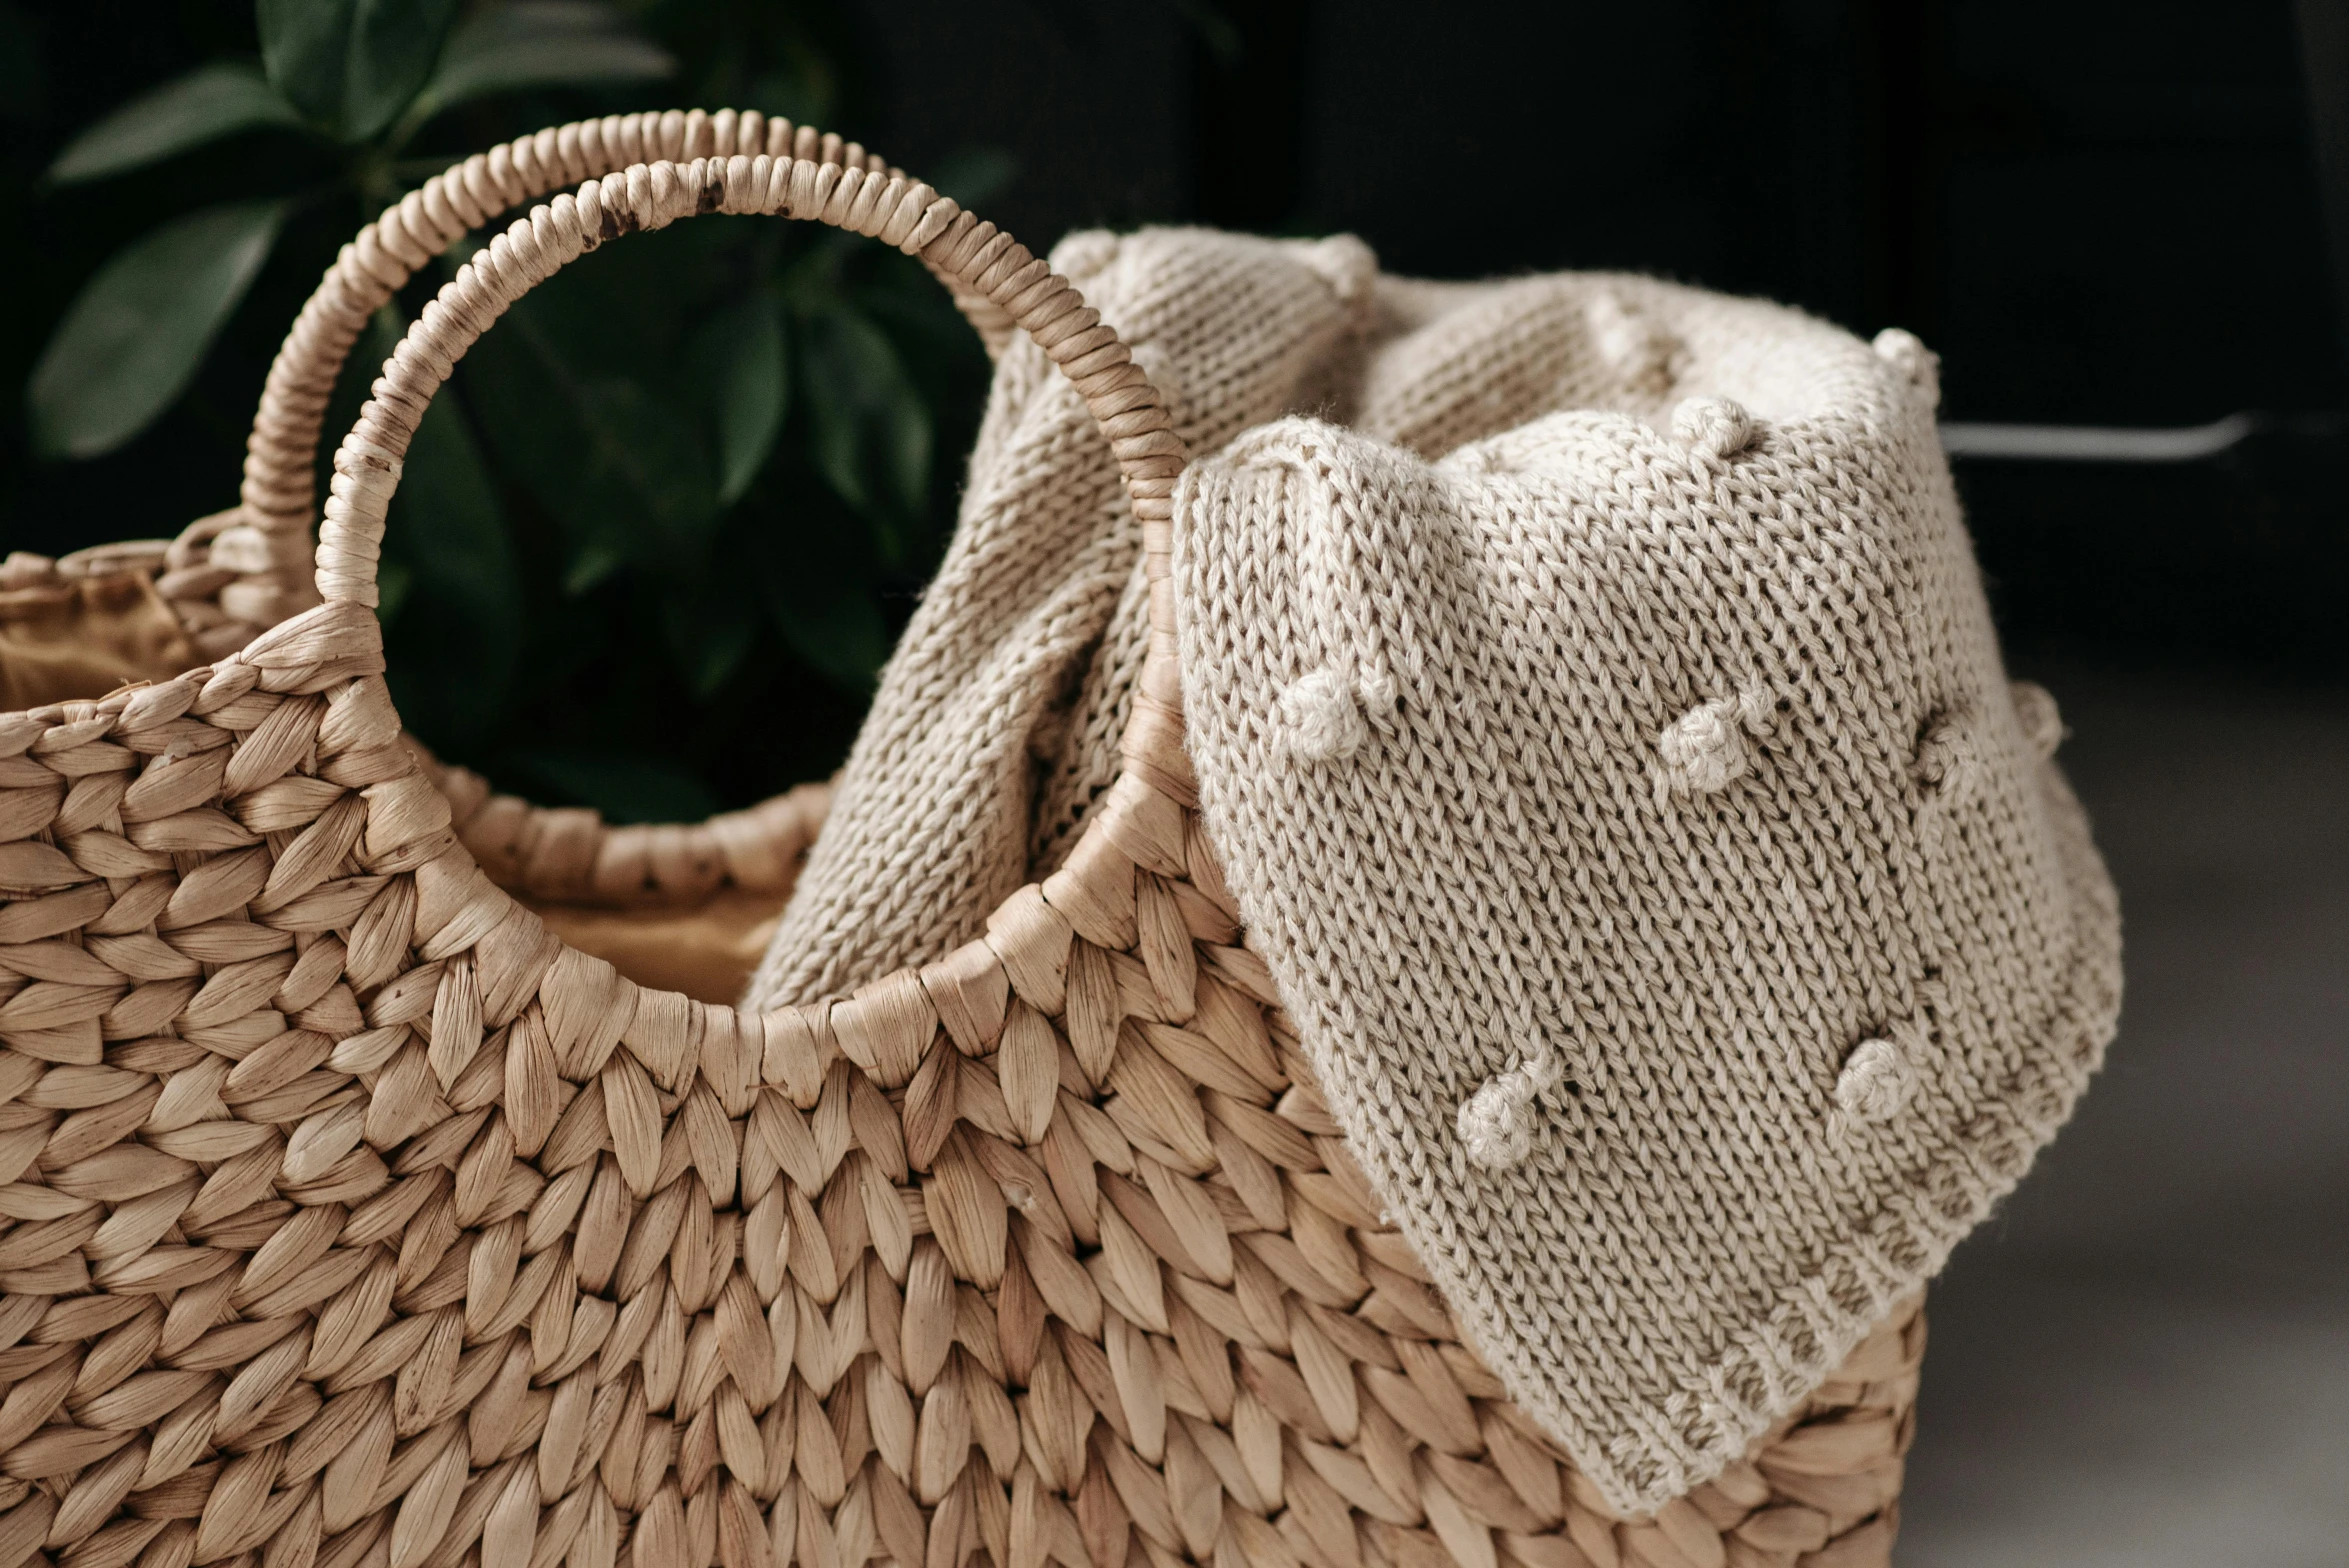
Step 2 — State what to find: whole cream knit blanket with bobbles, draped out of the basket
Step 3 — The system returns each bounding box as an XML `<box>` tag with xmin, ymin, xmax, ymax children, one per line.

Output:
<box><xmin>754</xmin><ymin>232</ymin><xmax>2119</xmax><ymax>1507</ymax></box>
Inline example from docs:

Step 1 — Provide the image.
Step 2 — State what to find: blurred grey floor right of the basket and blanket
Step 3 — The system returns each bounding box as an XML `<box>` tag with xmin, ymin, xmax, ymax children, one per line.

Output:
<box><xmin>1896</xmin><ymin>655</ymin><xmax>2349</xmax><ymax>1568</ymax></box>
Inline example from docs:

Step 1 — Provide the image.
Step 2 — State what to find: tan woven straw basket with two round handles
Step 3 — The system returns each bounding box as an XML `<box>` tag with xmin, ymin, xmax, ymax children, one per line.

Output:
<box><xmin>0</xmin><ymin>110</ymin><xmax>1924</xmax><ymax>1568</ymax></box>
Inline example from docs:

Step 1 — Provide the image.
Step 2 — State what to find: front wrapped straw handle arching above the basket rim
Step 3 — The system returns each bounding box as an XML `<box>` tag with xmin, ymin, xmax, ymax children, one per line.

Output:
<box><xmin>317</xmin><ymin>153</ymin><xmax>1184</xmax><ymax>605</ymax></box>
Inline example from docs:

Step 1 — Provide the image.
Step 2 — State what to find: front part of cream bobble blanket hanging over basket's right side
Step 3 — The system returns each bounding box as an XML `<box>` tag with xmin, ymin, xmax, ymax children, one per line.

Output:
<box><xmin>1172</xmin><ymin>262</ymin><xmax>2119</xmax><ymax>1514</ymax></box>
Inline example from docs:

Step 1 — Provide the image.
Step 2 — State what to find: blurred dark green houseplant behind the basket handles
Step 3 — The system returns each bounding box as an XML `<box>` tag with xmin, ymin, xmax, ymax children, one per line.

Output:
<box><xmin>2</xmin><ymin>0</ymin><xmax>987</xmax><ymax>822</ymax></box>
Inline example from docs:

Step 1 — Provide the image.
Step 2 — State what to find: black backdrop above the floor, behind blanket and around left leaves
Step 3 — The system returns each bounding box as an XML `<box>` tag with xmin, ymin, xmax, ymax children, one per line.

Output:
<box><xmin>13</xmin><ymin>0</ymin><xmax>2349</xmax><ymax>678</ymax></box>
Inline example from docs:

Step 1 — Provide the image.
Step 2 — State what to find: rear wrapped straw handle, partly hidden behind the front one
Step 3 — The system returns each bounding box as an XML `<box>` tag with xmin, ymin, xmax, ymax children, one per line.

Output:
<box><xmin>220</xmin><ymin>108</ymin><xmax>1012</xmax><ymax>629</ymax></box>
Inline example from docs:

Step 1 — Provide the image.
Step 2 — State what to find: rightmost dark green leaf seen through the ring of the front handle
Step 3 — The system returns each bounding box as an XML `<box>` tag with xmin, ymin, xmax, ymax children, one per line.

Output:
<box><xmin>796</xmin><ymin>293</ymin><xmax>930</xmax><ymax>539</ymax></box>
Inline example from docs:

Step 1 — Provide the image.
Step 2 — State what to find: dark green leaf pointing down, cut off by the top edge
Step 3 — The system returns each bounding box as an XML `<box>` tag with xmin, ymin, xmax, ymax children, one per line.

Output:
<box><xmin>254</xmin><ymin>0</ymin><xmax>456</xmax><ymax>141</ymax></box>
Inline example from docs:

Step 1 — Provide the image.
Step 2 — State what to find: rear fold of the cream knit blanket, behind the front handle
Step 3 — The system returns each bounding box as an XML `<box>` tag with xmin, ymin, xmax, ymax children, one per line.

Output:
<box><xmin>745</xmin><ymin>230</ymin><xmax>1374</xmax><ymax>1007</ymax></box>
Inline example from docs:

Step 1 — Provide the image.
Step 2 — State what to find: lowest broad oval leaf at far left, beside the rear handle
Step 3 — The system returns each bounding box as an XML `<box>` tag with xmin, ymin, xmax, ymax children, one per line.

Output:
<box><xmin>26</xmin><ymin>202</ymin><xmax>287</xmax><ymax>458</ymax></box>
